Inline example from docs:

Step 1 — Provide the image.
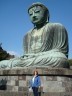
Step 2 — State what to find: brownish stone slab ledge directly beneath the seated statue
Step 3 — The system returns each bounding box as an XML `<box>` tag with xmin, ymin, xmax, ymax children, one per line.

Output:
<box><xmin>0</xmin><ymin>67</ymin><xmax>72</xmax><ymax>76</ymax></box>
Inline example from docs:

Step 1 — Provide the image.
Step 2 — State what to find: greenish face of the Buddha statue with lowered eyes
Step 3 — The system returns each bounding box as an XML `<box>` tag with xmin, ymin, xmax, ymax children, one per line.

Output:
<box><xmin>29</xmin><ymin>6</ymin><xmax>45</xmax><ymax>25</ymax></box>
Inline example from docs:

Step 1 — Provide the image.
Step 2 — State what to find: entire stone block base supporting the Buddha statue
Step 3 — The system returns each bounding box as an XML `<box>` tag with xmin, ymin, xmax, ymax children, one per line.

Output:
<box><xmin>0</xmin><ymin>67</ymin><xmax>72</xmax><ymax>96</ymax></box>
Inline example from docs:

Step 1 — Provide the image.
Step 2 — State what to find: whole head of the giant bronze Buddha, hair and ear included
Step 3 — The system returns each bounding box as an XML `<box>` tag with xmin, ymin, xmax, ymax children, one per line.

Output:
<box><xmin>28</xmin><ymin>3</ymin><xmax>49</xmax><ymax>25</ymax></box>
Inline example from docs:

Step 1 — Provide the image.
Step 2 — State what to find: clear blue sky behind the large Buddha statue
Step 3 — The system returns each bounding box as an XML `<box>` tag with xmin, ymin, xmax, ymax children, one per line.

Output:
<box><xmin>0</xmin><ymin>0</ymin><xmax>72</xmax><ymax>59</ymax></box>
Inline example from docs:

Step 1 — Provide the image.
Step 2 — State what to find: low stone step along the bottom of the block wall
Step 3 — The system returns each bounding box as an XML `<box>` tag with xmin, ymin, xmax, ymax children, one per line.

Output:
<box><xmin>0</xmin><ymin>91</ymin><xmax>72</xmax><ymax>96</ymax></box>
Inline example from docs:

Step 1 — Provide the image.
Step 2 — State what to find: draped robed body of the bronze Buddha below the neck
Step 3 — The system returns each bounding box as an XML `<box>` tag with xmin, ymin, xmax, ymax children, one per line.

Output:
<box><xmin>0</xmin><ymin>23</ymin><xmax>69</xmax><ymax>68</ymax></box>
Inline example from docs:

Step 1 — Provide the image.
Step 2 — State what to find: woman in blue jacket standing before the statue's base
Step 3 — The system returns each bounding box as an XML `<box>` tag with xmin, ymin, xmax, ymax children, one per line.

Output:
<box><xmin>30</xmin><ymin>70</ymin><xmax>41</xmax><ymax>96</ymax></box>
